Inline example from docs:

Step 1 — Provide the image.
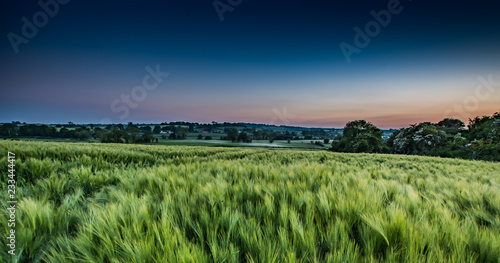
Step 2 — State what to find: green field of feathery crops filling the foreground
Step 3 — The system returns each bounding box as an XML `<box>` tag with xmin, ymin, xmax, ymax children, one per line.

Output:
<box><xmin>0</xmin><ymin>141</ymin><xmax>500</xmax><ymax>263</ymax></box>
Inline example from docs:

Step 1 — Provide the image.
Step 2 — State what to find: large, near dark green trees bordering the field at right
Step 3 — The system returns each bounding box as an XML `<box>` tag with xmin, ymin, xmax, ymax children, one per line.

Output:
<box><xmin>331</xmin><ymin>112</ymin><xmax>500</xmax><ymax>161</ymax></box>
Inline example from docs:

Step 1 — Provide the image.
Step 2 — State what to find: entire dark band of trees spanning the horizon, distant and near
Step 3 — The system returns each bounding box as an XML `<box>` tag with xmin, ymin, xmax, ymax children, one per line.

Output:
<box><xmin>0</xmin><ymin>112</ymin><xmax>500</xmax><ymax>161</ymax></box>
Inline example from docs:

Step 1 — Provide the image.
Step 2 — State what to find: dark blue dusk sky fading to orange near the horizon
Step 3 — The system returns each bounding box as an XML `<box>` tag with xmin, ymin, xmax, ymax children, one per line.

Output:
<box><xmin>0</xmin><ymin>0</ymin><xmax>500</xmax><ymax>129</ymax></box>
